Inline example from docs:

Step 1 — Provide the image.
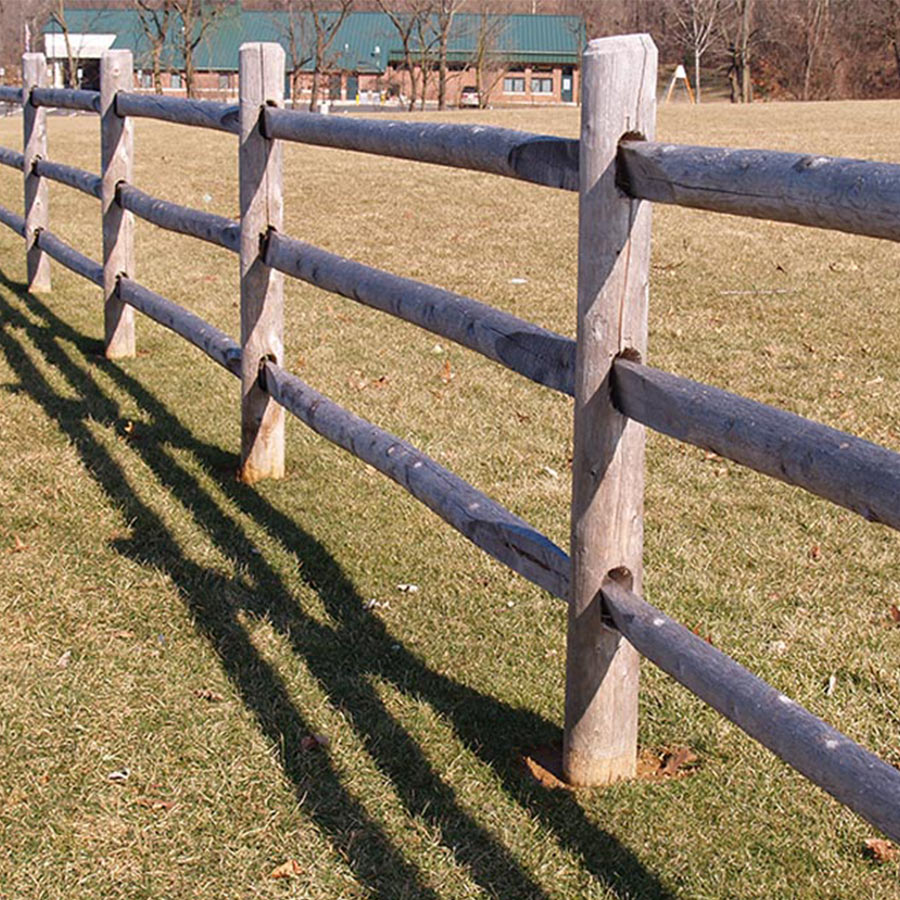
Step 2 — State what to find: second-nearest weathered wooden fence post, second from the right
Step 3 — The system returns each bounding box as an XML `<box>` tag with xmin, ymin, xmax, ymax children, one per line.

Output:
<box><xmin>239</xmin><ymin>44</ymin><xmax>284</xmax><ymax>484</ymax></box>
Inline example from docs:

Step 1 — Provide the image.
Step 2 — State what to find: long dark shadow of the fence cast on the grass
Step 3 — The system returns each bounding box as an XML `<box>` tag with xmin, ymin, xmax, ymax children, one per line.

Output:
<box><xmin>0</xmin><ymin>270</ymin><xmax>673</xmax><ymax>900</ymax></box>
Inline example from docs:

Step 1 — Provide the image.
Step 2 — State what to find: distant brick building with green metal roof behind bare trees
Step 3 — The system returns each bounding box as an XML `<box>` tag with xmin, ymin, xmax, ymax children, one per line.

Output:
<box><xmin>44</xmin><ymin>3</ymin><xmax>585</xmax><ymax>105</ymax></box>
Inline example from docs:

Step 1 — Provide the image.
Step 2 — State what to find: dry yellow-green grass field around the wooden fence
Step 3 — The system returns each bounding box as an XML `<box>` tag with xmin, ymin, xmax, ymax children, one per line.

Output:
<box><xmin>0</xmin><ymin>95</ymin><xmax>900</xmax><ymax>900</ymax></box>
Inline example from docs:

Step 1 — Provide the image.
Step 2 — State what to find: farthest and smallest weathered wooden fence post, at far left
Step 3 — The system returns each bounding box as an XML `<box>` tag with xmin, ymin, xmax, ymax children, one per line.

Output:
<box><xmin>22</xmin><ymin>53</ymin><xmax>50</xmax><ymax>292</ymax></box>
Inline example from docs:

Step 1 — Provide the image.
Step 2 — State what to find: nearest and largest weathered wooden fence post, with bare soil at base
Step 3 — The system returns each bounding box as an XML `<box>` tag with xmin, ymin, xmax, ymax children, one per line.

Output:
<box><xmin>563</xmin><ymin>34</ymin><xmax>656</xmax><ymax>785</ymax></box>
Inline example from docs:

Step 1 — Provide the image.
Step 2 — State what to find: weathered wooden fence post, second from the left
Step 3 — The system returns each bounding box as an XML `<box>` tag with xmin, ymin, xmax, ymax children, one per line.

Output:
<box><xmin>100</xmin><ymin>50</ymin><xmax>135</xmax><ymax>359</ymax></box>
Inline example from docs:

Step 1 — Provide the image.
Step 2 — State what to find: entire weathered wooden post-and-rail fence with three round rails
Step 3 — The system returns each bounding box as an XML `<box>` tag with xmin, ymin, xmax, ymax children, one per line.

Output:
<box><xmin>0</xmin><ymin>35</ymin><xmax>900</xmax><ymax>840</ymax></box>
